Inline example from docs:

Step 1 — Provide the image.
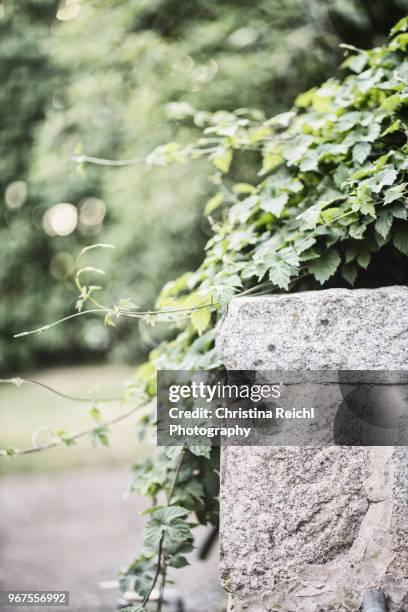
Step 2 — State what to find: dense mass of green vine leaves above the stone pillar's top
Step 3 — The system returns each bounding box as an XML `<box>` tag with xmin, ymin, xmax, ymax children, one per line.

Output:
<box><xmin>152</xmin><ymin>20</ymin><xmax>408</xmax><ymax>322</ymax></box>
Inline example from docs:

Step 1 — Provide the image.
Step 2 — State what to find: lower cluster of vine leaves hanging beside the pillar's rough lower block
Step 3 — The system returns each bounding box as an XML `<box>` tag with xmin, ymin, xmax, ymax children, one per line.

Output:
<box><xmin>121</xmin><ymin>447</ymin><xmax>219</xmax><ymax>597</ymax></box>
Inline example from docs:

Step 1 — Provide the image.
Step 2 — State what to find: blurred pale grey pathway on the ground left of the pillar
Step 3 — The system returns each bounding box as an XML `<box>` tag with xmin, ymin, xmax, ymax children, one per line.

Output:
<box><xmin>0</xmin><ymin>468</ymin><xmax>222</xmax><ymax>612</ymax></box>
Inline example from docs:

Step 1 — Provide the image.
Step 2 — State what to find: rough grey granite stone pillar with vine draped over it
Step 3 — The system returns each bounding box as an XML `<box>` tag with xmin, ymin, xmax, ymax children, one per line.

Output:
<box><xmin>217</xmin><ymin>287</ymin><xmax>408</xmax><ymax>612</ymax></box>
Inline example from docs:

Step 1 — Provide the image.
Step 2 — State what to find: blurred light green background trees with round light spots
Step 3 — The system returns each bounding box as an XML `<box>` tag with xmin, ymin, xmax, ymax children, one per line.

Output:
<box><xmin>0</xmin><ymin>0</ymin><xmax>408</xmax><ymax>364</ymax></box>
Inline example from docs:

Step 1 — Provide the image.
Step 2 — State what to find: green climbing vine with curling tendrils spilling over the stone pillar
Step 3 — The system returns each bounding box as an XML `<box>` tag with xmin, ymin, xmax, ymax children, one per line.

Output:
<box><xmin>0</xmin><ymin>18</ymin><xmax>408</xmax><ymax>612</ymax></box>
